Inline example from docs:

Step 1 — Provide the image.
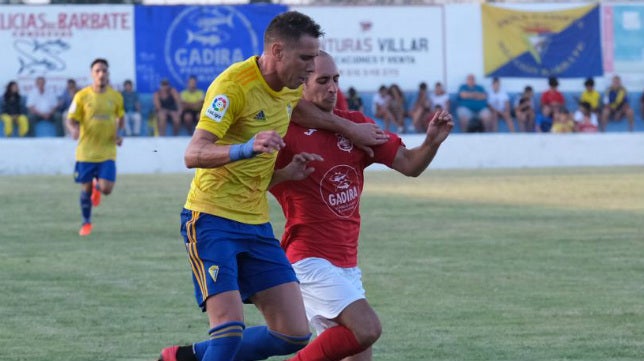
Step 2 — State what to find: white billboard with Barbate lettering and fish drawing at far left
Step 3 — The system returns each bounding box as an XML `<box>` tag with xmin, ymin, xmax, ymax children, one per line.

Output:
<box><xmin>0</xmin><ymin>5</ymin><xmax>134</xmax><ymax>95</ymax></box>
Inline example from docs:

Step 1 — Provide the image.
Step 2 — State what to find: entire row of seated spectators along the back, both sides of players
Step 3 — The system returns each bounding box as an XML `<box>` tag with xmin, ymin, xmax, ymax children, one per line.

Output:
<box><xmin>0</xmin><ymin>74</ymin><xmax>644</xmax><ymax>137</ymax></box>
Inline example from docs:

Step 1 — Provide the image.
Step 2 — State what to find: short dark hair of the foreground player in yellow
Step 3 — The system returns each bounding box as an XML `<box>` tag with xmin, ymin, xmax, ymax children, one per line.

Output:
<box><xmin>264</xmin><ymin>11</ymin><xmax>324</xmax><ymax>46</ymax></box>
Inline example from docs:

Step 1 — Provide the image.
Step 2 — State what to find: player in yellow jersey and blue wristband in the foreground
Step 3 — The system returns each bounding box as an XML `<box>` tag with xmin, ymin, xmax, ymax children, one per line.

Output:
<box><xmin>159</xmin><ymin>11</ymin><xmax>386</xmax><ymax>361</ymax></box>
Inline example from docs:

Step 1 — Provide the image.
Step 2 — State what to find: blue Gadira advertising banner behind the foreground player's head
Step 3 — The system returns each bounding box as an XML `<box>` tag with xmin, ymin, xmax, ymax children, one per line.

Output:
<box><xmin>135</xmin><ymin>4</ymin><xmax>287</xmax><ymax>93</ymax></box>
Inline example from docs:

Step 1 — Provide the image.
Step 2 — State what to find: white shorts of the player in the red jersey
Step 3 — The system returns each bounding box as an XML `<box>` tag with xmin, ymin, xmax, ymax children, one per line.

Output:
<box><xmin>293</xmin><ymin>258</ymin><xmax>365</xmax><ymax>334</ymax></box>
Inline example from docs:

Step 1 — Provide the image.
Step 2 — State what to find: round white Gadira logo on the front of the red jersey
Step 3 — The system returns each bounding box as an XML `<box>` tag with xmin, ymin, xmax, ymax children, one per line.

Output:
<box><xmin>320</xmin><ymin>165</ymin><xmax>361</xmax><ymax>218</ymax></box>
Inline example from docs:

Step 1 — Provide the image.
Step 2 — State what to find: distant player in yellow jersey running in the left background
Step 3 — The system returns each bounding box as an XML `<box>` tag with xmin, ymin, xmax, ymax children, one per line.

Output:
<box><xmin>66</xmin><ymin>58</ymin><xmax>125</xmax><ymax>236</ymax></box>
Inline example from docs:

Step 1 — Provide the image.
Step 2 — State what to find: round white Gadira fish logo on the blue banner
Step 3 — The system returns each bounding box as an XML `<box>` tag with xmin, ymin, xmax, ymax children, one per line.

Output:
<box><xmin>164</xmin><ymin>6</ymin><xmax>262</xmax><ymax>84</ymax></box>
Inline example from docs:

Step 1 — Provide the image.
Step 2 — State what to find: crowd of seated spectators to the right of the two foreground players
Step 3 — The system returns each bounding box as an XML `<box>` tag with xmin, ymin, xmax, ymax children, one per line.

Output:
<box><xmin>358</xmin><ymin>74</ymin><xmax>644</xmax><ymax>133</ymax></box>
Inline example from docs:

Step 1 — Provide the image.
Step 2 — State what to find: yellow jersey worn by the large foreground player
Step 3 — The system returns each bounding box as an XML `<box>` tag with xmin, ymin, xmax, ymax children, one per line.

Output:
<box><xmin>185</xmin><ymin>56</ymin><xmax>302</xmax><ymax>224</ymax></box>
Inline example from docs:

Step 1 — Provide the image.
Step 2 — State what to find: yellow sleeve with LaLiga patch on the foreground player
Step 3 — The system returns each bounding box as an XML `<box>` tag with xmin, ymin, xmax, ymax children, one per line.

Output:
<box><xmin>197</xmin><ymin>80</ymin><xmax>245</xmax><ymax>139</ymax></box>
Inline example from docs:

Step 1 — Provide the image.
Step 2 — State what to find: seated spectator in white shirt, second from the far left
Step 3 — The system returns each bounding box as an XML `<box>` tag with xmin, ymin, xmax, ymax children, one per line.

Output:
<box><xmin>27</xmin><ymin>76</ymin><xmax>63</xmax><ymax>136</ymax></box>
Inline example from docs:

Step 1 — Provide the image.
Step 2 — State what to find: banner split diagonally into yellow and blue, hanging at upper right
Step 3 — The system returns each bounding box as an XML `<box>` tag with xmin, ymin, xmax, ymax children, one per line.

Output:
<box><xmin>481</xmin><ymin>4</ymin><xmax>603</xmax><ymax>78</ymax></box>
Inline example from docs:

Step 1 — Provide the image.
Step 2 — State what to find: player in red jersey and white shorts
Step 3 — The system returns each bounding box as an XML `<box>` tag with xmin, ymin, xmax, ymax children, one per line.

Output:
<box><xmin>270</xmin><ymin>52</ymin><xmax>454</xmax><ymax>361</ymax></box>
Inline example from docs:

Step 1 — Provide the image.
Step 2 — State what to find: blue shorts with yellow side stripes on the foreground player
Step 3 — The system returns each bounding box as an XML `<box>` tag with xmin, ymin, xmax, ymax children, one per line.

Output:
<box><xmin>181</xmin><ymin>209</ymin><xmax>297</xmax><ymax>311</ymax></box>
